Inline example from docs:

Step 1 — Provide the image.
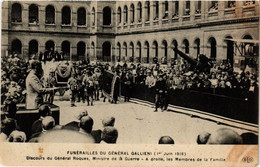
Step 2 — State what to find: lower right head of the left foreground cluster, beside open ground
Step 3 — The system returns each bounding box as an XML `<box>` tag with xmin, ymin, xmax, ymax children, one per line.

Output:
<box><xmin>100</xmin><ymin>126</ymin><xmax>118</xmax><ymax>144</ymax></box>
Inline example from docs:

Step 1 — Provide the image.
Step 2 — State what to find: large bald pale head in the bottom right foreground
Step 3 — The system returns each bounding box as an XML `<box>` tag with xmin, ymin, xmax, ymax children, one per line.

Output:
<box><xmin>207</xmin><ymin>128</ymin><xmax>243</xmax><ymax>144</ymax></box>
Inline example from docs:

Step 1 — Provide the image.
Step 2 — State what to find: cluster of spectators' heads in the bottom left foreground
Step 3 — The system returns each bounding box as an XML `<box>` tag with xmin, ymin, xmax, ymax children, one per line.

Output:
<box><xmin>0</xmin><ymin>104</ymin><xmax>118</xmax><ymax>143</ymax></box>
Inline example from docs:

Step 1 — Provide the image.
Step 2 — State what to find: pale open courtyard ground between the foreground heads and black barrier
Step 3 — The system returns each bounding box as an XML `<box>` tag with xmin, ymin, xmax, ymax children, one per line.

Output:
<box><xmin>54</xmin><ymin>91</ymin><xmax>252</xmax><ymax>144</ymax></box>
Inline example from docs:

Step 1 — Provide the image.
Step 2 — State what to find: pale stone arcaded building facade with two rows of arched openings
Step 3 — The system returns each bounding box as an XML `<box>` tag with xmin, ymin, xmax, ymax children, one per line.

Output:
<box><xmin>1</xmin><ymin>1</ymin><xmax>259</xmax><ymax>64</ymax></box>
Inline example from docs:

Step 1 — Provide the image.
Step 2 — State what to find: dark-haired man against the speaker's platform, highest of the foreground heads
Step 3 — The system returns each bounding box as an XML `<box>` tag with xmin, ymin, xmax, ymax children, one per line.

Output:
<box><xmin>31</xmin><ymin>104</ymin><xmax>51</xmax><ymax>134</ymax></box>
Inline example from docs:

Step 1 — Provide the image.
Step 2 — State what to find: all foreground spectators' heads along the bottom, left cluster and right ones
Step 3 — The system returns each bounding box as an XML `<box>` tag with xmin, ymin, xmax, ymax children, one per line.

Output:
<box><xmin>0</xmin><ymin>104</ymin><xmax>258</xmax><ymax>144</ymax></box>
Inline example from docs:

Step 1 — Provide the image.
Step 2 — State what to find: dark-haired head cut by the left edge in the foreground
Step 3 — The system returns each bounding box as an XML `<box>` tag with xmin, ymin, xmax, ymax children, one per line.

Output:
<box><xmin>0</xmin><ymin>118</ymin><xmax>17</xmax><ymax>141</ymax></box>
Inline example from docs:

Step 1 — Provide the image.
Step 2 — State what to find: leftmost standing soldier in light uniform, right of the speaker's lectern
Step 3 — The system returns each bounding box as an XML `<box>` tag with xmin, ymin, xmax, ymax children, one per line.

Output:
<box><xmin>67</xmin><ymin>73</ymin><xmax>78</xmax><ymax>107</ymax></box>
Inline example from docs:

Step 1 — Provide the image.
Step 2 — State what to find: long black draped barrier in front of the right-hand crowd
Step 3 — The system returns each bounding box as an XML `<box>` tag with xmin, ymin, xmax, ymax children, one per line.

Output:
<box><xmin>122</xmin><ymin>84</ymin><xmax>258</xmax><ymax>124</ymax></box>
